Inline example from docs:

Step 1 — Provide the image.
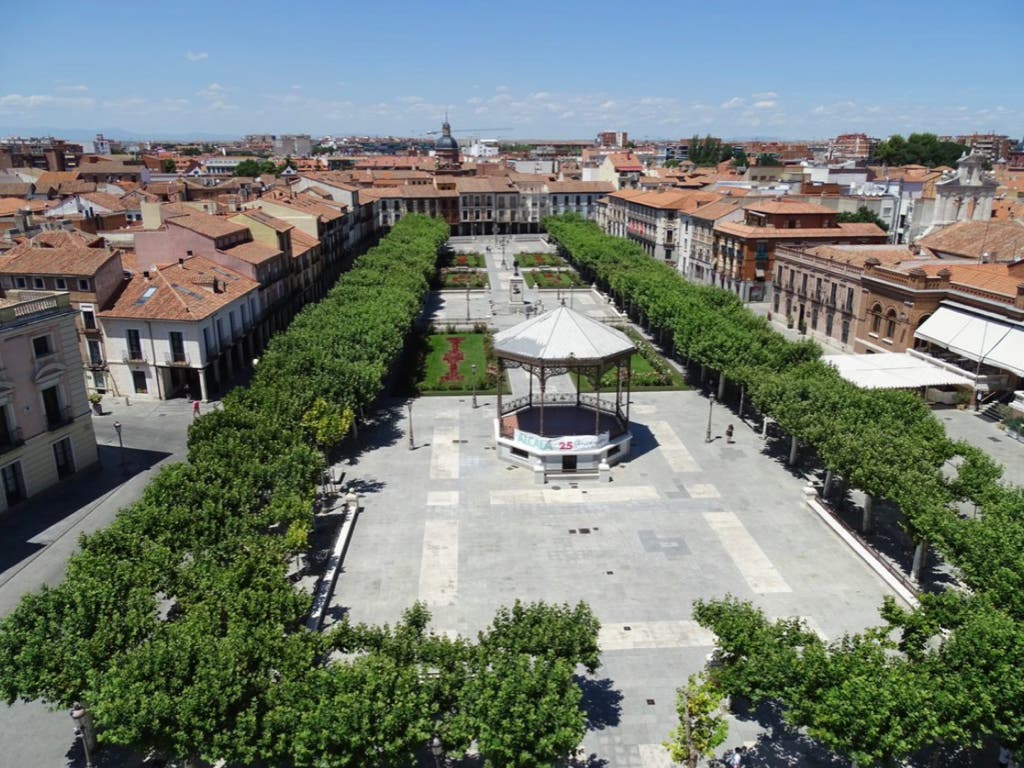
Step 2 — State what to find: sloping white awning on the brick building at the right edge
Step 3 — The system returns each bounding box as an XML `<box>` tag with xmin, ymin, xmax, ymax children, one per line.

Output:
<box><xmin>913</xmin><ymin>306</ymin><xmax>1024</xmax><ymax>376</ymax></box>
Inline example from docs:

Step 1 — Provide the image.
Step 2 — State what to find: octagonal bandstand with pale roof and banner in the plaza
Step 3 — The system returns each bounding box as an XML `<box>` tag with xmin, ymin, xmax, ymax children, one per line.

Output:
<box><xmin>495</xmin><ymin>306</ymin><xmax>635</xmax><ymax>473</ymax></box>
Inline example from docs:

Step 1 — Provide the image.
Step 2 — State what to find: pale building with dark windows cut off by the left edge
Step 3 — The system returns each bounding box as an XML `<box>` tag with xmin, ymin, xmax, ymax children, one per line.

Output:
<box><xmin>0</xmin><ymin>291</ymin><xmax>97</xmax><ymax>512</ymax></box>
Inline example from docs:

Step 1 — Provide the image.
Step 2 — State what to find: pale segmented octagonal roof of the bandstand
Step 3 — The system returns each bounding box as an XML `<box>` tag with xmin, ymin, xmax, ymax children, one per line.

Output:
<box><xmin>495</xmin><ymin>306</ymin><xmax>636</xmax><ymax>367</ymax></box>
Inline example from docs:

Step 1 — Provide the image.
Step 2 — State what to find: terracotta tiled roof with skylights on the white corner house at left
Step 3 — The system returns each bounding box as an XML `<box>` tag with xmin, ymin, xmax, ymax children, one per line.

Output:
<box><xmin>100</xmin><ymin>256</ymin><xmax>259</xmax><ymax>321</ymax></box>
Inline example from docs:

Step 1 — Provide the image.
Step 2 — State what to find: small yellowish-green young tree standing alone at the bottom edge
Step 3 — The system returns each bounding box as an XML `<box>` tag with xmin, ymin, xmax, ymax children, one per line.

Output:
<box><xmin>665</xmin><ymin>673</ymin><xmax>729</xmax><ymax>768</ymax></box>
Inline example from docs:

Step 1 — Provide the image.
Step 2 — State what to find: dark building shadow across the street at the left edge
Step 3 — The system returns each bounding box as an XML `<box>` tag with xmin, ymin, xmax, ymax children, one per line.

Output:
<box><xmin>0</xmin><ymin>445</ymin><xmax>170</xmax><ymax>572</ymax></box>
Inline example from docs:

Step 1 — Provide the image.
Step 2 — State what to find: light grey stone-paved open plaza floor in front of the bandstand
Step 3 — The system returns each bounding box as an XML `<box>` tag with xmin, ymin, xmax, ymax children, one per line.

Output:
<box><xmin>331</xmin><ymin>391</ymin><xmax>905</xmax><ymax>768</ymax></box>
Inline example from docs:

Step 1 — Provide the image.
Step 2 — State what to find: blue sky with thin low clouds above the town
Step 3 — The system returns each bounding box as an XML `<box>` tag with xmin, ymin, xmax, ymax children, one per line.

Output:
<box><xmin>0</xmin><ymin>0</ymin><xmax>1024</xmax><ymax>140</ymax></box>
